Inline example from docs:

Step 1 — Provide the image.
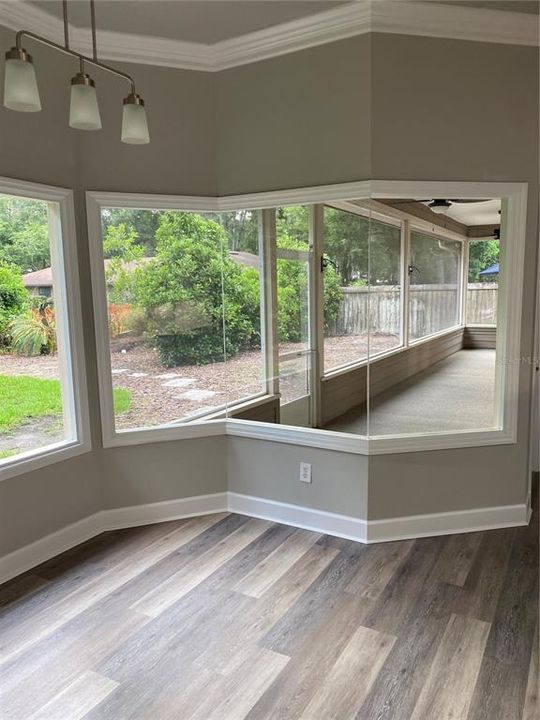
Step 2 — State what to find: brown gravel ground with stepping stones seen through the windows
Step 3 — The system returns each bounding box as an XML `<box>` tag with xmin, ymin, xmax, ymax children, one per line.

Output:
<box><xmin>0</xmin><ymin>336</ymin><xmax>397</xmax><ymax>429</ymax></box>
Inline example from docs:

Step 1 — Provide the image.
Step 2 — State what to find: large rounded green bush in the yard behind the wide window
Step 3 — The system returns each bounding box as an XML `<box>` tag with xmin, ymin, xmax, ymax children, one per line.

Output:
<box><xmin>132</xmin><ymin>212</ymin><xmax>260</xmax><ymax>367</ymax></box>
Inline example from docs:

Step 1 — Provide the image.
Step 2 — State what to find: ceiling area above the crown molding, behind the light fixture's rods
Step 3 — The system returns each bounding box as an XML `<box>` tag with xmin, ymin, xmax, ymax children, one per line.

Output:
<box><xmin>29</xmin><ymin>0</ymin><xmax>346</xmax><ymax>45</ymax></box>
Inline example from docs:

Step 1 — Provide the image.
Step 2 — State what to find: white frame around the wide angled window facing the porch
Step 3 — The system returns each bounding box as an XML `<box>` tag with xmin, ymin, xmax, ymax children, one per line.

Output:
<box><xmin>86</xmin><ymin>180</ymin><xmax>528</xmax><ymax>455</ymax></box>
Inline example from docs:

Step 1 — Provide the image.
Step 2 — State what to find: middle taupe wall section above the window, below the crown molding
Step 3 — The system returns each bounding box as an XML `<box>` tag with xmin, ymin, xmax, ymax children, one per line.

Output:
<box><xmin>217</xmin><ymin>35</ymin><xmax>371</xmax><ymax>195</ymax></box>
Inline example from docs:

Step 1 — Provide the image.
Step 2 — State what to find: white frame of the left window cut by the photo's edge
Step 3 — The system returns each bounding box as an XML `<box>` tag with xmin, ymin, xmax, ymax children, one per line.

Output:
<box><xmin>0</xmin><ymin>177</ymin><xmax>91</xmax><ymax>480</ymax></box>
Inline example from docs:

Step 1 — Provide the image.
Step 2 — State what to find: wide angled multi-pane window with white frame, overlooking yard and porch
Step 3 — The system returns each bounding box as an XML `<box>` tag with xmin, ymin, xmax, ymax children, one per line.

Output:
<box><xmin>89</xmin><ymin>185</ymin><xmax>524</xmax><ymax>451</ymax></box>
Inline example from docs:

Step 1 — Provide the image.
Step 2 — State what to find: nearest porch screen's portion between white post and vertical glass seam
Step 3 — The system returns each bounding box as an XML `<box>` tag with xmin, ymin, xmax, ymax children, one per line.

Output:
<box><xmin>323</xmin><ymin>207</ymin><xmax>369</xmax><ymax>373</ymax></box>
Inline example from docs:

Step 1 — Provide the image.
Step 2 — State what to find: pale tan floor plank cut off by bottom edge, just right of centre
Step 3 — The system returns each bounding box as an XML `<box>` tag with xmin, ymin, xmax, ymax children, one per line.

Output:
<box><xmin>300</xmin><ymin>627</ymin><xmax>396</xmax><ymax>720</ymax></box>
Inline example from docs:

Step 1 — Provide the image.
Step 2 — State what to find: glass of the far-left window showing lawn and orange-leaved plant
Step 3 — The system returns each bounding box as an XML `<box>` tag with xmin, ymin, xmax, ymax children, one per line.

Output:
<box><xmin>0</xmin><ymin>195</ymin><xmax>74</xmax><ymax>461</ymax></box>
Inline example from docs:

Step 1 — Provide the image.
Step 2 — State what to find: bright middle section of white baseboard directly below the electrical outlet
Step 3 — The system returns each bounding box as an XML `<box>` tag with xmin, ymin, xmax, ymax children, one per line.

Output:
<box><xmin>229</xmin><ymin>492</ymin><xmax>366</xmax><ymax>542</ymax></box>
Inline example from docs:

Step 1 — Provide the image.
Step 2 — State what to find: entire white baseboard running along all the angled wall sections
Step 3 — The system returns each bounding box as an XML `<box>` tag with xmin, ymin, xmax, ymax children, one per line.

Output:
<box><xmin>0</xmin><ymin>492</ymin><xmax>530</xmax><ymax>583</ymax></box>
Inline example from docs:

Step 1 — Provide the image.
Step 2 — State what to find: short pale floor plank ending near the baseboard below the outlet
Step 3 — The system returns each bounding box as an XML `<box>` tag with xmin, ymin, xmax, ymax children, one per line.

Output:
<box><xmin>233</xmin><ymin>530</ymin><xmax>321</xmax><ymax>597</ymax></box>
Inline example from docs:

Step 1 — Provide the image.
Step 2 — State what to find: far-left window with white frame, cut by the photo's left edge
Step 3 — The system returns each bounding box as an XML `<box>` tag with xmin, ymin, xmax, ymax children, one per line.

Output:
<box><xmin>0</xmin><ymin>180</ymin><xmax>87</xmax><ymax>472</ymax></box>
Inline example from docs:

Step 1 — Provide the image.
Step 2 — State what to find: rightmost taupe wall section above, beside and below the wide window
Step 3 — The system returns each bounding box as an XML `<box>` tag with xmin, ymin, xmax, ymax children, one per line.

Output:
<box><xmin>369</xmin><ymin>35</ymin><xmax>538</xmax><ymax>518</ymax></box>
